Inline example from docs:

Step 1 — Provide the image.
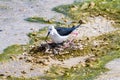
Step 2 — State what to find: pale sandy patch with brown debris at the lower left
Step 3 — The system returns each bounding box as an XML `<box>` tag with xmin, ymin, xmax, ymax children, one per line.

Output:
<box><xmin>0</xmin><ymin>53</ymin><xmax>92</xmax><ymax>78</ymax></box>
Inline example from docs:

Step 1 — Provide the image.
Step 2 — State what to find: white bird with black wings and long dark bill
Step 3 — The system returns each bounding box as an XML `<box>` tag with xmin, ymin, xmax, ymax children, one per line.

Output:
<box><xmin>45</xmin><ymin>24</ymin><xmax>80</xmax><ymax>43</ymax></box>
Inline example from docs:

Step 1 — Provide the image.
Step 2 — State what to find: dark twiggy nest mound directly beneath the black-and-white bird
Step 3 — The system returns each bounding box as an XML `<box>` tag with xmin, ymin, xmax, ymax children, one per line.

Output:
<box><xmin>29</xmin><ymin>41</ymin><xmax>83</xmax><ymax>54</ymax></box>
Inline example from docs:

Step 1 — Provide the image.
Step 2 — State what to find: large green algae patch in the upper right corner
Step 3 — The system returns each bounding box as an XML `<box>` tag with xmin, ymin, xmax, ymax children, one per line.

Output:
<box><xmin>53</xmin><ymin>0</ymin><xmax>120</xmax><ymax>27</ymax></box>
